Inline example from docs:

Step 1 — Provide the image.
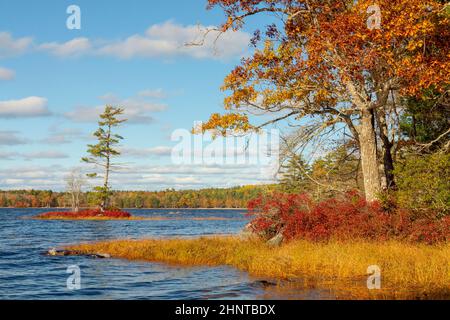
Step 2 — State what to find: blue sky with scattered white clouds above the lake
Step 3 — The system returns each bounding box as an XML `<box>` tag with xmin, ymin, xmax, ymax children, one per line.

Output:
<box><xmin>0</xmin><ymin>0</ymin><xmax>282</xmax><ymax>190</ymax></box>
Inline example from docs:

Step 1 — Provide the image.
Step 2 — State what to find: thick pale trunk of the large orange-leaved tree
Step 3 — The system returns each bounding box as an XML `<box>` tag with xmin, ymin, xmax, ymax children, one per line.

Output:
<box><xmin>358</xmin><ymin>108</ymin><xmax>381</xmax><ymax>201</ymax></box>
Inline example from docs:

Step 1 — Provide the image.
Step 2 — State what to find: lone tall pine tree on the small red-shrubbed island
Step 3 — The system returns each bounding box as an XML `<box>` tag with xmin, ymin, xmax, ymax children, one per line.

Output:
<box><xmin>82</xmin><ymin>106</ymin><xmax>126</xmax><ymax>212</ymax></box>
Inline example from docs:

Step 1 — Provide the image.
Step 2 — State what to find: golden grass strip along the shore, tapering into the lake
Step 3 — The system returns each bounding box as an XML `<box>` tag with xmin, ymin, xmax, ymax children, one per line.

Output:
<box><xmin>66</xmin><ymin>236</ymin><xmax>450</xmax><ymax>299</ymax></box>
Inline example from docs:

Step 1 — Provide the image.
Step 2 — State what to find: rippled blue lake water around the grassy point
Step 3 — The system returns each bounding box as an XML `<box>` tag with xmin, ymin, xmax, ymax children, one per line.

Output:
<box><xmin>0</xmin><ymin>209</ymin><xmax>314</xmax><ymax>299</ymax></box>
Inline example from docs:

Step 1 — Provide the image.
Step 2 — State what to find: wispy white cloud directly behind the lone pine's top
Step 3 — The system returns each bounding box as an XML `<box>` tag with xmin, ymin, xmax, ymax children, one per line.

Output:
<box><xmin>65</xmin><ymin>94</ymin><xmax>167</xmax><ymax>124</ymax></box>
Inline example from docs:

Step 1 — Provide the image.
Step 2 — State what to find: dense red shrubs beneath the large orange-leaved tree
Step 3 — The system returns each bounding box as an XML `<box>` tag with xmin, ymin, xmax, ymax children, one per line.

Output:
<box><xmin>248</xmin><ymin>192</ymin><xmax>450</xmax><ymax>244</ymax></box>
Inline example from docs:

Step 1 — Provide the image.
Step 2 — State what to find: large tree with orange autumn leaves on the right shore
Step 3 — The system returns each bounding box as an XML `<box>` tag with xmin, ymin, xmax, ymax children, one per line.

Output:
<box><xmin>202</xmin><ymin>0</ymin><xmax>450</xmax><ymax>201</ymax></box>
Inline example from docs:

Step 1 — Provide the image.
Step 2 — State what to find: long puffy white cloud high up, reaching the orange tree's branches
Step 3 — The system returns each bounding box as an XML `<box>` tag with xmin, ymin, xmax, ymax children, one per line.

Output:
<box><xmin>38</xmin><ymin>21</ymin><xmax>250</xmax><ymax>59</ymax></box>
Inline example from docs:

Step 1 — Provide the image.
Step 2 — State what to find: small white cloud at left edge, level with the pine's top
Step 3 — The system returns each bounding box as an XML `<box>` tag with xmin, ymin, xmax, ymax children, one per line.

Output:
<box><xmin>0</xmin><ymin>97</ymin><xmax>50</xmax><ymax>118</ymax></box>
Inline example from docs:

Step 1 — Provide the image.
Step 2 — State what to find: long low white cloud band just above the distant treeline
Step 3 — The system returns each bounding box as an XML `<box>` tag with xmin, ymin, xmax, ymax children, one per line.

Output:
<box><xmin>0</xmin><ymin>165</ymin><xmax>273</xmax><ymax>191</ymax></box>
